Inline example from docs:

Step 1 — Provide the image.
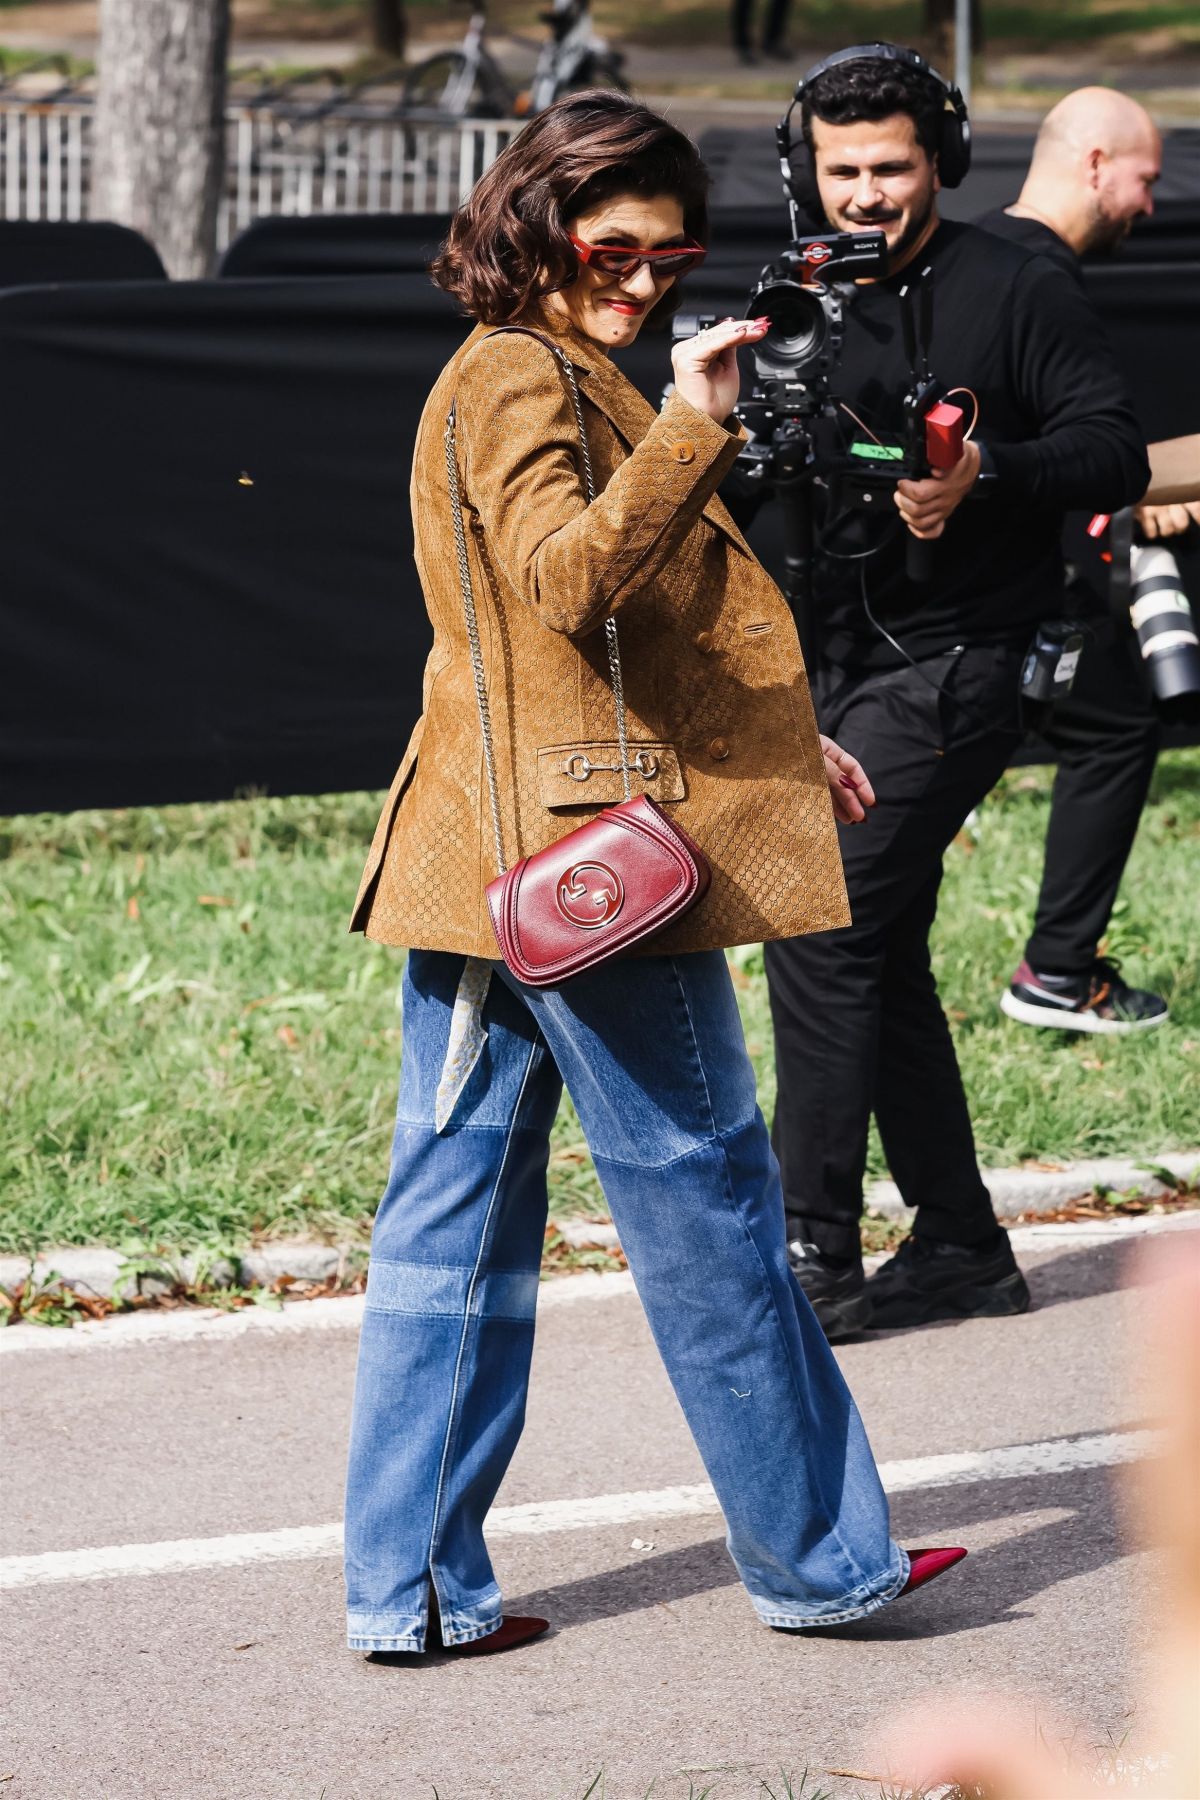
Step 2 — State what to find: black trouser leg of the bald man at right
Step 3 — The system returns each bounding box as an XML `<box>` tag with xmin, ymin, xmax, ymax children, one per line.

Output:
<box><xmin>1025</xmin><ymin>621</ymin><xmax>1160</xmax><ymax>976</ymax></box>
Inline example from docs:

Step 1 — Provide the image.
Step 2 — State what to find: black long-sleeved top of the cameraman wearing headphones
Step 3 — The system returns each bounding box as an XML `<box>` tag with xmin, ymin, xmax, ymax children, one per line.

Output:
<box><xmin>817</xmin><ymin>221</ymin><xmax>1150</xmax><ymax>668</ymax></box>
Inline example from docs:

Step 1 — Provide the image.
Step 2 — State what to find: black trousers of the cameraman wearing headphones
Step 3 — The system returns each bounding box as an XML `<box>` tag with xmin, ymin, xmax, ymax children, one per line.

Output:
<box><xmin>765</xmin><ymin>646</ymin><xmax>1022</xmax><ymax>1256</ymax></box>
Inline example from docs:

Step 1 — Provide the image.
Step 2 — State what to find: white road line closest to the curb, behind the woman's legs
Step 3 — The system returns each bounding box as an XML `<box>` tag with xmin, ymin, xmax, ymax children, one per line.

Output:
<box><xmin>0</xmin><ymin>1211</ymin><xmax>1200</xmax><ymax>1355</ymax></box>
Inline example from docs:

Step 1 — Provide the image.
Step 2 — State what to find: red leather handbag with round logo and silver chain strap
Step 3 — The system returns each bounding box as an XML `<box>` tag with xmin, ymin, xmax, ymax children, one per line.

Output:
<box><xmin>444</xmin><ymin>326</ymin><xmax>712</xmax><ymax>988</ymax></box>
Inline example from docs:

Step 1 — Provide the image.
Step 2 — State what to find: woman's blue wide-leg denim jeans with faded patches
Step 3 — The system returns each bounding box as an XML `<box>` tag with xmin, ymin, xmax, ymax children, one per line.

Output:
<box><xmin>345</xmin><ymin>950</ymin><xmax>909</xmax><ymax>1651</ymax></box>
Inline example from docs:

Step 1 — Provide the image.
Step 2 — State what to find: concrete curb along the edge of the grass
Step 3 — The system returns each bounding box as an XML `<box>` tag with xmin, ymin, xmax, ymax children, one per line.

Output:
<box><xmin>0</xmin><ymin>1150</ymin><xmax>1200</xmax><ymax>1296</ymax></box>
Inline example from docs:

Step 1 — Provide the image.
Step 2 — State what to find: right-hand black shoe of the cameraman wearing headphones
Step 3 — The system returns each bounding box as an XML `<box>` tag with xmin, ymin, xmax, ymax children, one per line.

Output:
<box><xmin>865</xmin><ymin>1231</ymin><xmax>1029</xmax><ymax>1330</ymax></box>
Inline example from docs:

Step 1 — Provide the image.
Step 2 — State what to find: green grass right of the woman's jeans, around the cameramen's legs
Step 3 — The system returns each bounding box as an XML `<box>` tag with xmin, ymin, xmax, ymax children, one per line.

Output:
<box><xmin>736</xmin><ymin>751</ymin><xmax>1200</xmax><ymax>1175</ymax></box>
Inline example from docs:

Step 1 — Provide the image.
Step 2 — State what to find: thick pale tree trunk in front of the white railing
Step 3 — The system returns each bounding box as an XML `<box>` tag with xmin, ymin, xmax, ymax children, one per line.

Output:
<box><xmin>90</xmin><ymin>0</ymin><xmax>230</xmax><ymax>277</ymax></box>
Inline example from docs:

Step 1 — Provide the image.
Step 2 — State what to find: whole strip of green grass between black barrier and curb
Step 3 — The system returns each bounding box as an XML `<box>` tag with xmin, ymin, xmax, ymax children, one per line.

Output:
<box><xmin>0</xmin><ymin>751</ymin><xmax>1200</xmax><ymax>1249</ymax></box>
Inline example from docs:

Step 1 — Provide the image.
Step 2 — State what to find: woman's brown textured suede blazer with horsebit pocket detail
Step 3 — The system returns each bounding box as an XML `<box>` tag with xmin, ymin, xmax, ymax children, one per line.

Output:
<box><xmin>351</xmin><ymin>315</ymin><xmax>849</xmax><ymax>958</ymax></box>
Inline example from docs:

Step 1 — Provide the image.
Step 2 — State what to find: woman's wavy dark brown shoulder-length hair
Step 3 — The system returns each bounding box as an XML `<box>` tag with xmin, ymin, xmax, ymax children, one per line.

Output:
<box><xmin>430</xmin><ymin>88</ymin><xmax>709</xmax><ymax>326</ymax></box>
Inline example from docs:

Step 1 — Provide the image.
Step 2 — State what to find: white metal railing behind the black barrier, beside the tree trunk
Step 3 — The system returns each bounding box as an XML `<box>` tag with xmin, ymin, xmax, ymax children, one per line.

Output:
<box><xmin>0</xmin><ymin>86</ymin><xmax>522</xmax><ymax>248</ymax></box>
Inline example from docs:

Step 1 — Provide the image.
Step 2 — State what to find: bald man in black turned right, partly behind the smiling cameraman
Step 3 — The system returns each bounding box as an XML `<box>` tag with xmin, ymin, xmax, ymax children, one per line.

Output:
<box><xmin>977</xmin><ymin>88</ymin><xmax>1200</xmax><ymax>1033</ymax></box>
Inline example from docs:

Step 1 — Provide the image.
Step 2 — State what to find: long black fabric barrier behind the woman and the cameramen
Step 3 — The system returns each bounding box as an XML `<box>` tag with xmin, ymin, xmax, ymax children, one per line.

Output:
<box><xmin>0</xmin><ymin>255</ymin><xmax>1200</xmax><ymax>812</ymax></box>
